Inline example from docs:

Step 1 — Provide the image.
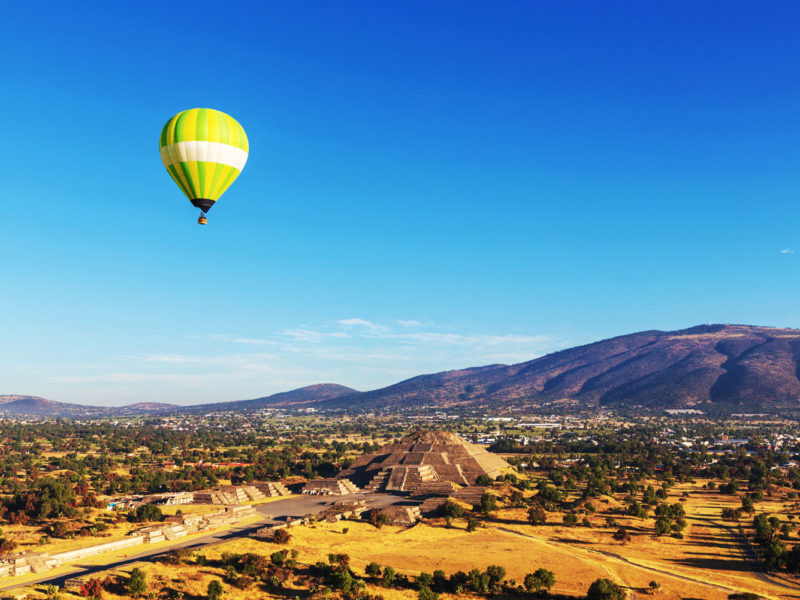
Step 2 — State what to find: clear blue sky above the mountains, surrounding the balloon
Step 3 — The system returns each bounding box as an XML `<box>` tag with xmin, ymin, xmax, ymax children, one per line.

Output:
<box><xmin>0</xmin><ymin>1</ymin><xmax>800</xmax><ymax>405</ymax></box>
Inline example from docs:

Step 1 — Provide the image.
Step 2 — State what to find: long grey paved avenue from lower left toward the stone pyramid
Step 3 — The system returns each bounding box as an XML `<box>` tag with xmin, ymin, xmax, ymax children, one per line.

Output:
<box><xmin>0</xmin><ymin>492</ymin><xmax>408</xmax><ymax>592</ymax></box>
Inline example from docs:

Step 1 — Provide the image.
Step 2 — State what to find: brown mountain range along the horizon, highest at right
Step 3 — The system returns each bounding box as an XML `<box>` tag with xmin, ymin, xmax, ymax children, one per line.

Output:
<box><xmin>0</xmin><ymin>325</ymin><xmax>800</xmax><ymax>416</ymax></box>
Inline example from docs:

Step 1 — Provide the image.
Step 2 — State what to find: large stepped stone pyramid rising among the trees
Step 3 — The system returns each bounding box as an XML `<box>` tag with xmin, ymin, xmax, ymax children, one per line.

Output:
<box><xmin>338</xmin><ymin>431</ymin><xmax>511</xmax><ymax>494</ymax></box>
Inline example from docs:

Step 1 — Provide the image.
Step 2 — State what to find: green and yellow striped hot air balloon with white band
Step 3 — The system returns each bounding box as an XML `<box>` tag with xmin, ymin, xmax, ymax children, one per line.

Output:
<box><xmin>158</xmin><ymin>108</ymin><xmax>249</xmax><ymax>225</ymax></box>
